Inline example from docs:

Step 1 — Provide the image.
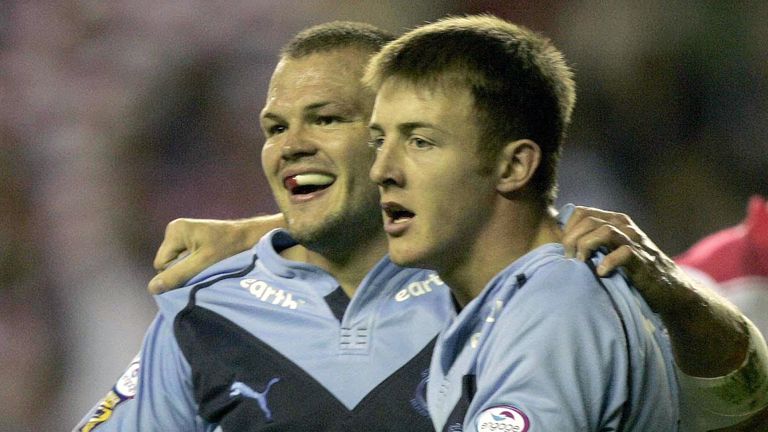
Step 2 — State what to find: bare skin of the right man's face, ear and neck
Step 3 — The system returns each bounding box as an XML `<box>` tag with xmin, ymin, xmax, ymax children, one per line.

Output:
<box><xmin>371</xmin><ymin>78</ymin><xmax>560</xmax><ymax>304</ymax></box>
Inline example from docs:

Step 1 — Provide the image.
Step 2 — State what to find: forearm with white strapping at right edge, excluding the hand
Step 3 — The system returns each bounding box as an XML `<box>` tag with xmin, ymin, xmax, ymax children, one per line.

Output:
<box><xmin>656</xmin><ymin>270</ymin><xmax>768</xmax><ymax>432</ymax></box>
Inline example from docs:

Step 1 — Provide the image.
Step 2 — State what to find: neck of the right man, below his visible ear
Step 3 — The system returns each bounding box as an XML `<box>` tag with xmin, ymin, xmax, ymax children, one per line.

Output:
<box><xmin>438</xmin><ymin>202</ymin><xmax>562</xmax><ymax>306</ymax></box>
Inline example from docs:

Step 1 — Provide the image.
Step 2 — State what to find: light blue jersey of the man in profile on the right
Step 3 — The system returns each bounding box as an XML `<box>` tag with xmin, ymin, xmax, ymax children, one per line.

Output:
<box><xmin>427</xmin><ymin>206</ymin><xmax>678</xmax><ymax>432</ymax></box>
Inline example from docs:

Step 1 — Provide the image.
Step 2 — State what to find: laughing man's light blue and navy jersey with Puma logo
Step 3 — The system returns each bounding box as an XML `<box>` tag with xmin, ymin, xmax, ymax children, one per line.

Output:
<box><xmin>77</xmin><ymin>230</ymin><xmax>454</xmax><ymax>432</ymax></box>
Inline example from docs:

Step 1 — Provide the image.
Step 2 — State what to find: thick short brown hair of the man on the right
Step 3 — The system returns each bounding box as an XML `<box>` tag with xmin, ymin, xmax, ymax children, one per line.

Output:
<box><xmin>364</xmin><ymin>15</ymin><xmax>576</xmax><ymax>204</ymax></box>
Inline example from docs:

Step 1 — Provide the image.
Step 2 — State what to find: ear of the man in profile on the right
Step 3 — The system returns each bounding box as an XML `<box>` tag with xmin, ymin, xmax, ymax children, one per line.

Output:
<box><xmin>496</xmin><ymin>139</ymin><xmax>541</xmax><ymax>194</ymax></box>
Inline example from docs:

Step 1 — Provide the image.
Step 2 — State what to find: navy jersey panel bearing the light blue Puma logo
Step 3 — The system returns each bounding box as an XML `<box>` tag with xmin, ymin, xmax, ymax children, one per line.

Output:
<box><xmin>175</xmin><ymin>307</ymin><xmax>347</xmax><ymax>431</ymax></box>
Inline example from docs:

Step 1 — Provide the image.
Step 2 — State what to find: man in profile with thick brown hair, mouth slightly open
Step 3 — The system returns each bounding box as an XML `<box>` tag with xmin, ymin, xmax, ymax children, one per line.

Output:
<box><xmin>365</xmin><ymin>16</ymin><xmax>680</xmax><ymax>432</ymax></box>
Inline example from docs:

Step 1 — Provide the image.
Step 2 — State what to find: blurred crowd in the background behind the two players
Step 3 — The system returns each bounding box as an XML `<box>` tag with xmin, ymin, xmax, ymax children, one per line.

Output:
<box><xmin>0</xmin><ymin>0</ymin><xmax>768</xmax><ymax>432</ymax></box>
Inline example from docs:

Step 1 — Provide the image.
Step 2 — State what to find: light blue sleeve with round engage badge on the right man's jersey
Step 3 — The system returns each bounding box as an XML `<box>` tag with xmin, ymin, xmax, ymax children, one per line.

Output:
<box><xmin>464</xmin><ymin>260</ymin><xmax>629</xmax><ymax>432</ymax></box>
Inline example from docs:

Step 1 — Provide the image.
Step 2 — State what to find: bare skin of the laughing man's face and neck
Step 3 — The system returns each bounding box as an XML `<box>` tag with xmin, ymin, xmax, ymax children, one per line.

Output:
<box><xmin>261</xmin><ymin>47</ymin><xmax>386</xmax><ymax>296</ymax></box>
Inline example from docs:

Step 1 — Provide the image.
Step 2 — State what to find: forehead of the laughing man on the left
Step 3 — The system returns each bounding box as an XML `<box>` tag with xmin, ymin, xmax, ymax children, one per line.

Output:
<box><xmin>265</xmin><ymin>47</ymin><xmax>373</xmax><ymax>111</ymax></box>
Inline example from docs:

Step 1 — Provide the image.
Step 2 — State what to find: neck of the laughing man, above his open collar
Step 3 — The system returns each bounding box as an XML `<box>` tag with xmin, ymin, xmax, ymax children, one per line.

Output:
<box><xmin>281</xmin><ymin>229</ymin><xmax>387</xmax><ymax>298</ymax></box>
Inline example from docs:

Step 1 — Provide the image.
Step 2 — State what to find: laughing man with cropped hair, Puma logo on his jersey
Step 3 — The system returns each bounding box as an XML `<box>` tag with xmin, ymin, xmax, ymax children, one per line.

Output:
<box><xmin>78</xmin><ymin>23</ymin><xmax>453</xmax><ymax>432</ymax></box>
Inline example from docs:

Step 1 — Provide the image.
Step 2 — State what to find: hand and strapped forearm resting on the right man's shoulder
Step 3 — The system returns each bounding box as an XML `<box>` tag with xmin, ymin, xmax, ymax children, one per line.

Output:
<box><xmin>563</xmin><ymin>208</ymin><xmax>768</xmax><ymax>432</ymax></box>
